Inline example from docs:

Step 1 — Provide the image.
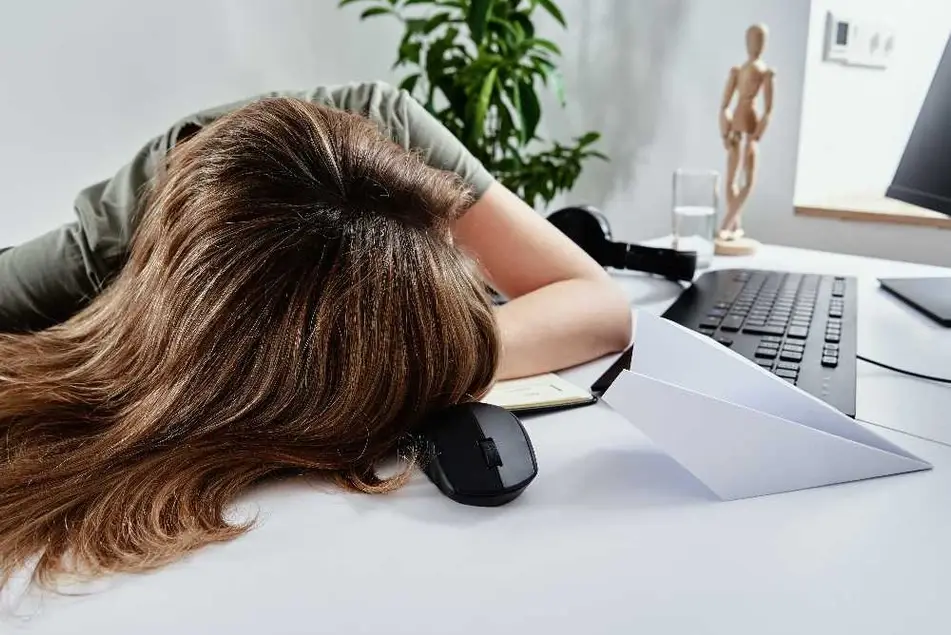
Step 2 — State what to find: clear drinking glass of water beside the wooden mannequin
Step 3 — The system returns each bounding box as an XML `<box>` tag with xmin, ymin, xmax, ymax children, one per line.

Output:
<box><xmin>673</xmin><ymin>170</ymin><xmax>720</xmax><ymax>268</ymax></box>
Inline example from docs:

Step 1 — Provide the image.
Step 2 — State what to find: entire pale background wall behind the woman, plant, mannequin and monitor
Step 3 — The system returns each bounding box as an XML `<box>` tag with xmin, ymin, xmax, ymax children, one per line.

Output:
<box><xmin>0</xmin><ymin>0</ymin><xmax>951</xmax><ymax>264</ymax></box>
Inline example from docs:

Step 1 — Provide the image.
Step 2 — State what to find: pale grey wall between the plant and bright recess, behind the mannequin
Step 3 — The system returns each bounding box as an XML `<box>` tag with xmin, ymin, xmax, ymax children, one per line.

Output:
<box><xmin>546</xmin><ymin>0</ymin><xmax>809</xmax><ymax>253</ymax></box>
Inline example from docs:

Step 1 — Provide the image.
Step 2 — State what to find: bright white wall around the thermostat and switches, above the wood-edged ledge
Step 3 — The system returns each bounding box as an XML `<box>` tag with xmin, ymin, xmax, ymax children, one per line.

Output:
<box><xmin>796</xmin><ymin>0</ymin><xmax>951</xmax><ymax>204</ymax></box>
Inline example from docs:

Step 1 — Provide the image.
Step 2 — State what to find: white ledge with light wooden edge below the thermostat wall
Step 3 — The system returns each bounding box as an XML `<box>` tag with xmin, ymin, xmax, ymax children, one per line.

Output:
<box><xmin>795</xmin><ymin>196</ymin><xmax>951</xmax><ymax>234</ymax></box>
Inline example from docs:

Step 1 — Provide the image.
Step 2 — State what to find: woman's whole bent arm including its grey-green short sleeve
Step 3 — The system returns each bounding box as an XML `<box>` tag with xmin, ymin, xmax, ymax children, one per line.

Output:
<box><xmin>386</xmin><ymin>84</ymin><xmax>632</xmax><ymax>379</ymax></box>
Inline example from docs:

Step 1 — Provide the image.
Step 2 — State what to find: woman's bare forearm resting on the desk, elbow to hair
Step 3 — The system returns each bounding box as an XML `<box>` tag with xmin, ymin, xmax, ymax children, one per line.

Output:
<box><xmin>497</xmin><ymin>279</ymin><xmax>633</xmax><ymax>379</ymax></box>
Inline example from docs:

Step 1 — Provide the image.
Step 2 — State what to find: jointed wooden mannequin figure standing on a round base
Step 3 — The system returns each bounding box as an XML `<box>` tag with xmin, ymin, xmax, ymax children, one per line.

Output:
<box><xmin>716</xmin><ymin>24</ymin><xmax>775</xmax><ymax>255</ymax></box>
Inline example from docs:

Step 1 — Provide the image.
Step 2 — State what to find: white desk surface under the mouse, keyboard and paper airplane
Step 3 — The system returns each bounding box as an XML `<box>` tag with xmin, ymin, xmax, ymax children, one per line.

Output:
<box><xmin>13</xmin><ymin>249</ymin><xmax>951</xmax><ymax>635</ymax></box>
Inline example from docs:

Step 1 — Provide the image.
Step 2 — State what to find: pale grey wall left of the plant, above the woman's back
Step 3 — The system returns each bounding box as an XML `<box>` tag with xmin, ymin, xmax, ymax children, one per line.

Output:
<box><xmin>0</xmin><ymin>0</ymin><xmax>399</xmax><ymax>245</ymax></box>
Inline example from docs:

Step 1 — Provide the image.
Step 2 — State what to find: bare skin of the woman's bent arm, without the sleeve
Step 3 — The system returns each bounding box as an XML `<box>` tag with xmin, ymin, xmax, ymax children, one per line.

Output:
<box><xmin>454</xmin><ymin>183</ymin><xmax>632</xmax><ymax>379</ymax></box>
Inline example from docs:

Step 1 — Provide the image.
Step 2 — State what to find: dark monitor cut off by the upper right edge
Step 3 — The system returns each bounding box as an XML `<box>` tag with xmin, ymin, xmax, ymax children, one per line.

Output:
<box><xmin>885</xmin><ymin>37</ymin><xmax>951</xmax><ymax>216</ymax></box>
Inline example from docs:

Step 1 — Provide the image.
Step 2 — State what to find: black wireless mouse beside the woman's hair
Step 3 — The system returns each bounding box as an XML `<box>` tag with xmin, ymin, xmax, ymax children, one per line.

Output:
<box><xmin>419</xmin><ymin>403</ymin><xmax>538</xmax><ymax>507</ymax></box>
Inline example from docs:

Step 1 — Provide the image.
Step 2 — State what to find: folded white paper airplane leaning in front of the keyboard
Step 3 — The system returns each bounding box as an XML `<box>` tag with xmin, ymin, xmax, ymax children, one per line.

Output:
<box><xmin>604</xmin><ymin>313</ymin><xmax>932</xmax><ymax>500</ymax></box>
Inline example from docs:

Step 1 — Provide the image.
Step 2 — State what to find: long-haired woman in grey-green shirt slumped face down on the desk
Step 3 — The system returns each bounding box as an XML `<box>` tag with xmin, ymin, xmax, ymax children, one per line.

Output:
<box><xmin>0</xmin><ymin>84</ymin><xmax>631</xmax><ymax>587</ymax></box>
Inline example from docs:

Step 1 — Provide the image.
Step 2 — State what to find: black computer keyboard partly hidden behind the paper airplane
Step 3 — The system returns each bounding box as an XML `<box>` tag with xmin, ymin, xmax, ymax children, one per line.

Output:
<box><xmin>592</xmin><ymin>269</ymin><xmax>858</xmax><ymax>417</ymax></box>
